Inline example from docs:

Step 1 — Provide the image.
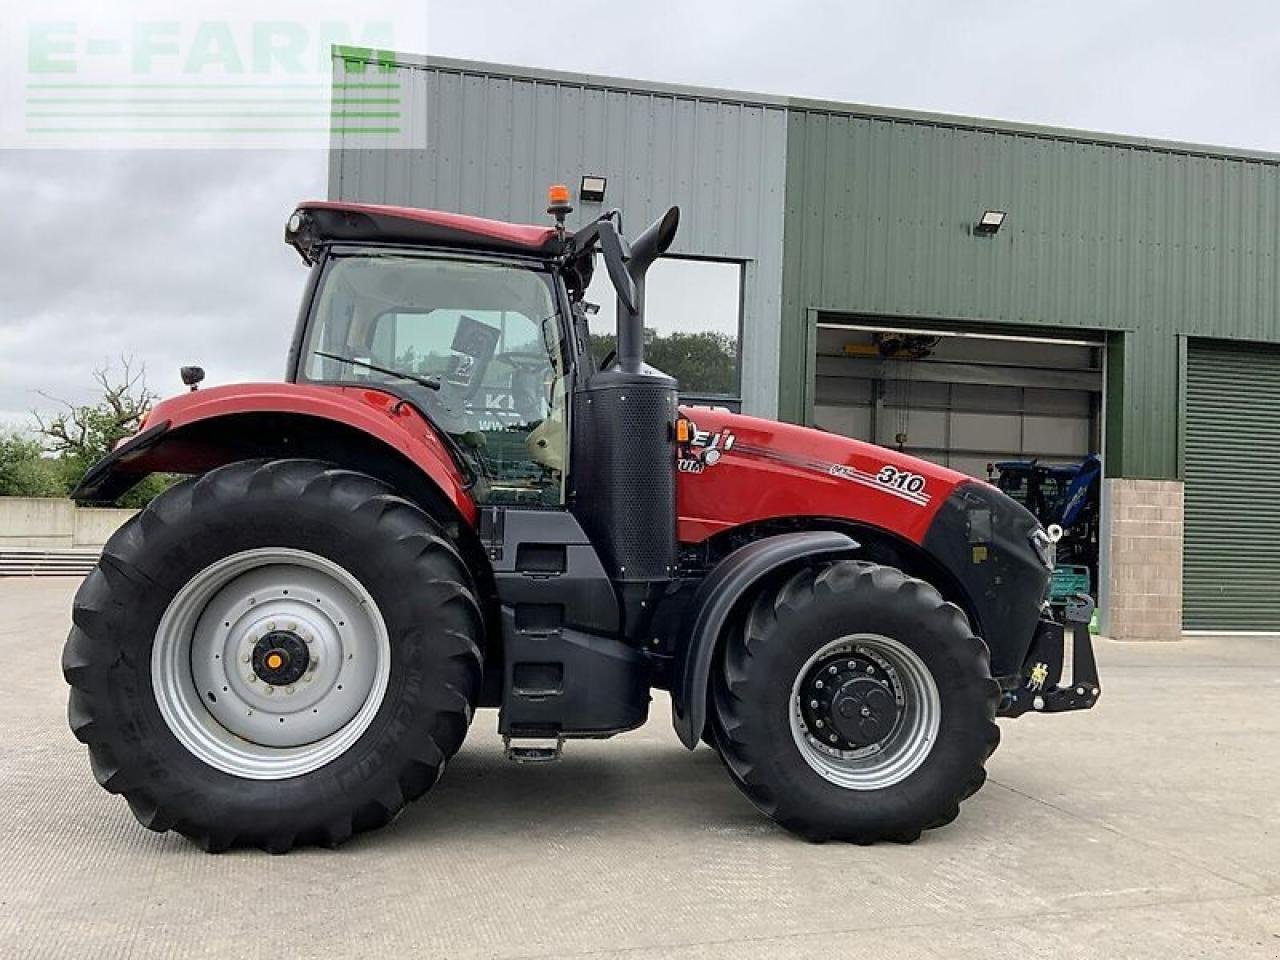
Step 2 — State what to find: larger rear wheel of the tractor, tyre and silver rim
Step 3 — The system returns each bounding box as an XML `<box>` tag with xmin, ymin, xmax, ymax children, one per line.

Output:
<box><xmin>63</xmin><ymin>460</ymin><xmax>481</xmax><ymax>852</ymax></box>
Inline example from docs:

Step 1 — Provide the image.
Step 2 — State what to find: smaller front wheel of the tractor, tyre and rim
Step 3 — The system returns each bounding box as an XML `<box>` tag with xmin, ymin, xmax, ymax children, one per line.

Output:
<box><xmin>713</xmin><ymin>561</ymin><xmax>1000</xmax><ymax>844</ymax></box>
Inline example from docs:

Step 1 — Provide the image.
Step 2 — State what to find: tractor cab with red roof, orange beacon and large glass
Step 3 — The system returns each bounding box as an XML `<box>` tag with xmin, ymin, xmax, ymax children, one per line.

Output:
<box><xmin>285</xmin><ymin>188</ymin><xmax>677</xmax><ymax>519</ymax></box>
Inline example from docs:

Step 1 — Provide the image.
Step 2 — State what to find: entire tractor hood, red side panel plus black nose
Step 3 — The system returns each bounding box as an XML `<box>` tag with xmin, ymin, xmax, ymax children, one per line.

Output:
<box><xmin>676</xmin><ymin>407</ymin><xmax>1051</xmax><ymax>673</ymax></box>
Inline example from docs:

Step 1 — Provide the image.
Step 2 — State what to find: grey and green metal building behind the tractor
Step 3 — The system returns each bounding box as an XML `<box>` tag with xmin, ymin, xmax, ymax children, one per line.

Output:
<box><xmin>330</xmin><ymin>56</ymin><xmax>1280</xmax><ymax>637</ymax></box>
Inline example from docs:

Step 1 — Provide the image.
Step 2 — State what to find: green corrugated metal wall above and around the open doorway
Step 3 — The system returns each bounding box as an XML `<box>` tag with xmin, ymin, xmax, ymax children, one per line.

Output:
<box><xmin>780</xmin><ymin>109</ymin><xmax>1280</xmax><ymax>477</ymax></box>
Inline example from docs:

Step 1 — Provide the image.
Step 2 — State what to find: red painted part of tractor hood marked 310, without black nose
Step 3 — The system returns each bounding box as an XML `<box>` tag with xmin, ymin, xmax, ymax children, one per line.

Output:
<box><xmin>677</xmin><ymin>407</ymin><xmax>977</xmax><ymax>543</ymax></box>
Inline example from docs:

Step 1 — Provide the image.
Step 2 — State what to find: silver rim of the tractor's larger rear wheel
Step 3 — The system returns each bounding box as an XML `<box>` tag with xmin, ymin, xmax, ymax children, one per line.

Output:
<box><xmin>151</xmin><ymin>547</ymin><xmax>390</xmax><ymax>780</ymax></box>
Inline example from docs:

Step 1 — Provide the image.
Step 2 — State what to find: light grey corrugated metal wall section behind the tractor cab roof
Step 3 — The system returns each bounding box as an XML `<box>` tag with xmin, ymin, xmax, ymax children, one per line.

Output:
<box><xmin>329</xmin><ymin>56</ymin><xmax>786</xmax><ymax>416</ymax></box>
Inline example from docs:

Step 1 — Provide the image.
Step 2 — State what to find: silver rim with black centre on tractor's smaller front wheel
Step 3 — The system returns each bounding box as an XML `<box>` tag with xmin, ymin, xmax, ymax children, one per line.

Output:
<box><xmin>790</xmin><ymin>634</ymin><xmax>942</xmax><ymax>790</ymax></box>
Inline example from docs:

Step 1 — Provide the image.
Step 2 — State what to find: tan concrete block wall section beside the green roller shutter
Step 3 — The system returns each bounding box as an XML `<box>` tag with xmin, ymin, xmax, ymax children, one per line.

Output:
<box><xmin>1105</xmin><ymin>479</ymin><xmax>1183</xmax><ymax>640</ymax></box>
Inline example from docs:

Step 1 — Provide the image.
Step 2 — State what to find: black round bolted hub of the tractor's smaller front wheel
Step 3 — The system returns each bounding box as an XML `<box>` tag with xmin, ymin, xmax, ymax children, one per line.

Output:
<box><xmin>800</xmin><ymin>652</ymin><xmax>900</xmax><ymax>751</ymax></box>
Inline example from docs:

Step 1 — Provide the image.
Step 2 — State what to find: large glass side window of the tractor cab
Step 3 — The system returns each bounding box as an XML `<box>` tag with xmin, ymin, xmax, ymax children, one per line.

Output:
<box><xmin>300</xmin><ymin>255</ymin><xmax>566</xmax><ymax>503</ymax></box>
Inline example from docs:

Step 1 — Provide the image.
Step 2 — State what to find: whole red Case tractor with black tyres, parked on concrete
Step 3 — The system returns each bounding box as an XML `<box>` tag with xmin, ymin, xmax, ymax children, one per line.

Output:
<box><xmin>63</xmin><ymin>192</ymin><xmax>1098</xmax><ymax>851</ymax></box>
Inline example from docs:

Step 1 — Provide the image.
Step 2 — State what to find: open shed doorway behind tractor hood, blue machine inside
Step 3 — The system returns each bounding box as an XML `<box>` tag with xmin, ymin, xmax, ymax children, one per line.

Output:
<box><xmin>814</xmin><ymin>319</ymin><xmax>1103</xmax><ymax>603</ymax></box>
